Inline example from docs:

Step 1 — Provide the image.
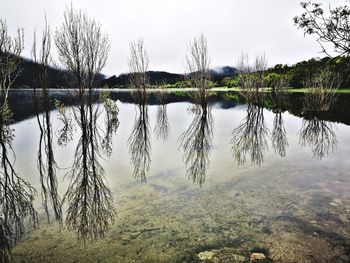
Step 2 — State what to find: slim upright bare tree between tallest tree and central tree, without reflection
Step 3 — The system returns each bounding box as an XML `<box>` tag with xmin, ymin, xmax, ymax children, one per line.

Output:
<box><xmin>129</xmin><ymin>38</ymin><xmax>149</xmax><ymax>105</ymax></box>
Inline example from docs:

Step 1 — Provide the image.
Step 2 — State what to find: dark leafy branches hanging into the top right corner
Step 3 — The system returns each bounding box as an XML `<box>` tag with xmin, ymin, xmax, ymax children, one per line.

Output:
<box><xmin>294</xmin><ymin>1</ymin><xmax>350</xmax><ymax>56</ymax></box>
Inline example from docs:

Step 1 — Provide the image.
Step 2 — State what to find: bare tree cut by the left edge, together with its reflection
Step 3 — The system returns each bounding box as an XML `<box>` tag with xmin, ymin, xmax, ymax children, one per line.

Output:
<box><xmin>0</xmin><ymin>19</ymin><xmax>37</xmax><ymax>262</ymax></box>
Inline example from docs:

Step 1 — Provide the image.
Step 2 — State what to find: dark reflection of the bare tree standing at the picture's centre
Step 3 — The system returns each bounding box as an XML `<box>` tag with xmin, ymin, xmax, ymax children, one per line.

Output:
<box><xmin>180</xmin><ymin>100</ymin><xmax>213</xmax><ymax>186</ymax></box>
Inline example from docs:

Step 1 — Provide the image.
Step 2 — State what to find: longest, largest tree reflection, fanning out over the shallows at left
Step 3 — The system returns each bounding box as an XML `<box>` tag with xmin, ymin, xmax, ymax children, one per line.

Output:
<box><xmin>64</xmin><ymin>95</ymin><xmax>115</xmax><ymax>242</ymax></box>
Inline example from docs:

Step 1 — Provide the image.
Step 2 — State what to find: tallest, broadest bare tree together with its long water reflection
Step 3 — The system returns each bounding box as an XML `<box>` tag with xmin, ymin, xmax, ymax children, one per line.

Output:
<box><xmin>55</xmin><ymin>6</ymin><xmax>117</xmax><ymax>242</ymax></box>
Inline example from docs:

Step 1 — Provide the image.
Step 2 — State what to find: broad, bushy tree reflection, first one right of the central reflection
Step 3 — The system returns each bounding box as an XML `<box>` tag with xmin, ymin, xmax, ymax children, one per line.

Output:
<box><xmin>231</xmin><ymin>104</ymin><xmax>269</xmax><ymax>166</ymax></box>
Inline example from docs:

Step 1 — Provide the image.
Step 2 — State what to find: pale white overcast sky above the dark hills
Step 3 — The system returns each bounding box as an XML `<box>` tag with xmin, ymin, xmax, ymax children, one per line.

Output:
<box><xmin>0</xmin><ymin>0</ymin><xmax>344</xmax><ymax>75</ymax></box>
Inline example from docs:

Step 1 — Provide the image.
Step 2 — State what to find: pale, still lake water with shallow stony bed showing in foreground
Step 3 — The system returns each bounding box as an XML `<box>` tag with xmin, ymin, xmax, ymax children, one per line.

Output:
<box><xmin>2</xmin><ymin>90</ymin><xmax>350</xmax><ymax>262</ymax></box>
